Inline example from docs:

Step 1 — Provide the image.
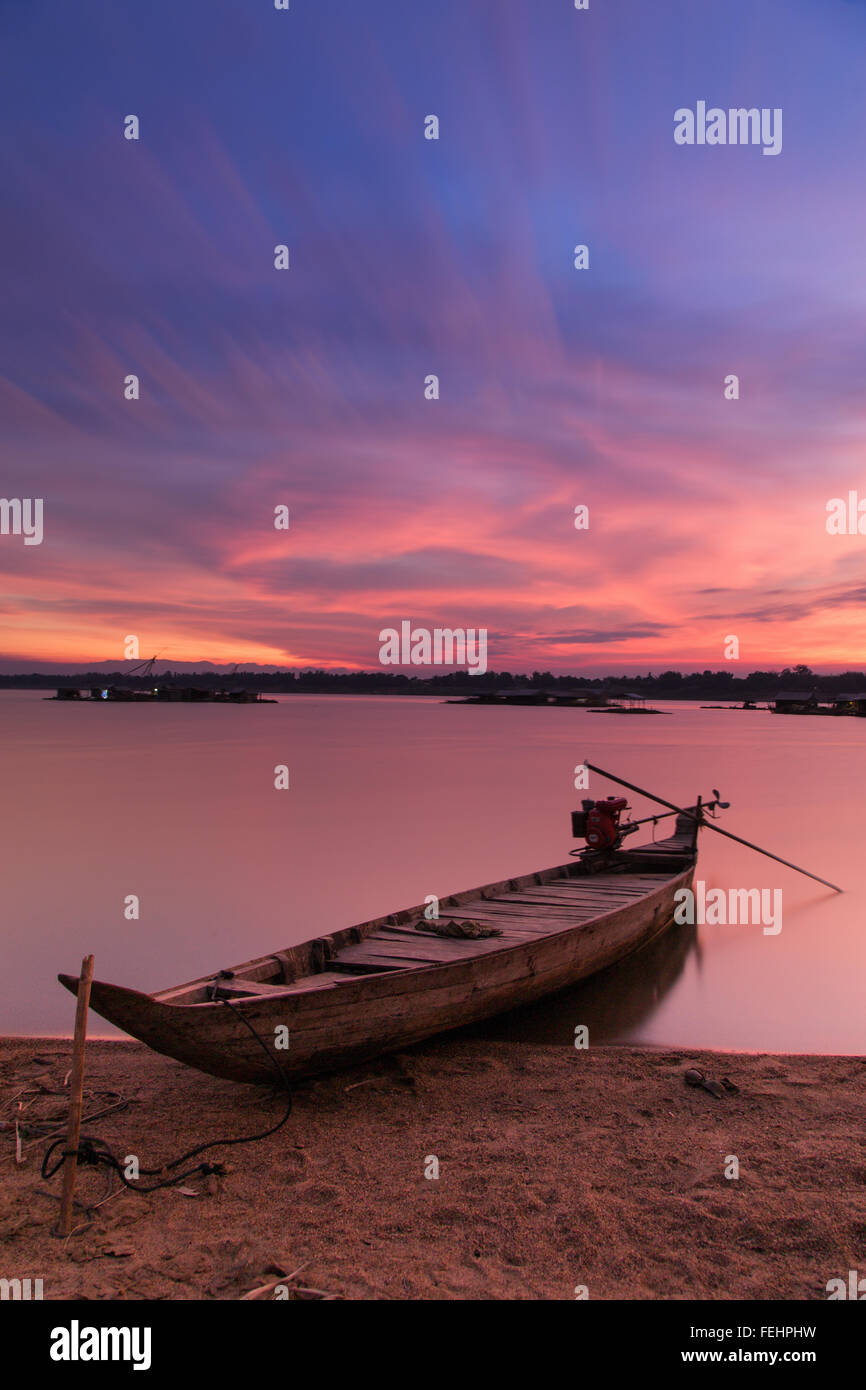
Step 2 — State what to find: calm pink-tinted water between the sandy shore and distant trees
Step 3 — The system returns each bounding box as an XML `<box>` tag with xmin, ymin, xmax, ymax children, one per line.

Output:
<box><xmin>0</xmin><ymin>691</ymin><xmax>866</xmax><ymax>1054</ymax></box>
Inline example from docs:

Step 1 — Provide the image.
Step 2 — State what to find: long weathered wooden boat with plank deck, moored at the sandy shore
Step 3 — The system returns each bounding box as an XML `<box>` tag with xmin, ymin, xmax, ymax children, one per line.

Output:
<box><xmin>58</xmin><ymin>798</ymin><xmax>713</xmax><ymax>1083</ymax></box>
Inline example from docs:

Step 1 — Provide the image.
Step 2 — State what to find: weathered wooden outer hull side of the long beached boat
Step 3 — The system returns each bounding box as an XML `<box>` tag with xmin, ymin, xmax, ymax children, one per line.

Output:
<box><xmin>58</xmin><ymin>856</ymin><xmax>694</xmax><ymax>1084</ymax></box>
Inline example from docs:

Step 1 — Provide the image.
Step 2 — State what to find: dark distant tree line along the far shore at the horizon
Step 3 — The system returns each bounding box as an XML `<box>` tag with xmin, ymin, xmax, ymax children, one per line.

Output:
<box><xmin>0</xmin><ymin>666</ymin><xmax>866</xmax><ymax>701</ymax></box>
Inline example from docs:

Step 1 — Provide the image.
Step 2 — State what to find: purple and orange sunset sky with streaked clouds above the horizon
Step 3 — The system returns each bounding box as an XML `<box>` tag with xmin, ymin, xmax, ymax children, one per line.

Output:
<box><xmin>0</xmin><ymin>0</ymin><xmax>866</xmax><ymax>674</ymax></box>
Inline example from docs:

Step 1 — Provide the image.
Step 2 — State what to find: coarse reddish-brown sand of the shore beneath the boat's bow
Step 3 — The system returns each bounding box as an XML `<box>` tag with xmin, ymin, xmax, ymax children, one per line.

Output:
<box><xmin>0</xmin><ymin>1036</ymin><xmax>866</xmax><ymax>1300</ymax></box>
